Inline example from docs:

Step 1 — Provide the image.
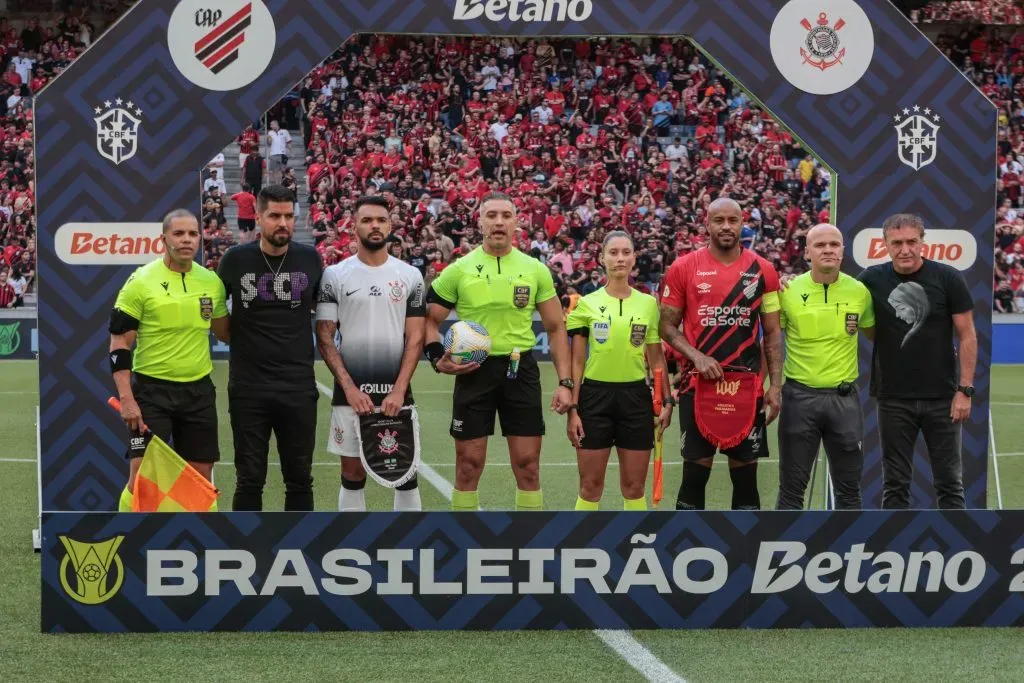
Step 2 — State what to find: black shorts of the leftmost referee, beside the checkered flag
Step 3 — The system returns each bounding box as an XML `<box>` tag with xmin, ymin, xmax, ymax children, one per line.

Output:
<box><xmin>125</xmin><ymin>374</ymin><xmax>220</xmax><ymax>463</ymax></box>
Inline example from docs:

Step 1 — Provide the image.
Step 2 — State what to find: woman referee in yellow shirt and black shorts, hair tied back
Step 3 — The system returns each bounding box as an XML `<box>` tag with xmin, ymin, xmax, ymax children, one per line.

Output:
<box><xmin>565</xmin><ymin>230</ymin><xmax>675</xmax><ymax>510</ymax></box>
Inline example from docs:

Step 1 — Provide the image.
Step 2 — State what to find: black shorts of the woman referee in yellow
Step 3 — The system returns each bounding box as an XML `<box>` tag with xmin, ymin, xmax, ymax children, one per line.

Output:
<box><xmin>580</xmin><ymin>380</ymin><xmax>654</xmax><ymax>451</ymax></box>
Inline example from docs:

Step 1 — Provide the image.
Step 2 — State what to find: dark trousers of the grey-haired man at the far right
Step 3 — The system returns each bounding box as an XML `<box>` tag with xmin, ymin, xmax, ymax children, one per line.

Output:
<box><xmin>879</xmin><ymin>396</ymin><xmax>966</xmax><ymax>510</ymax></box>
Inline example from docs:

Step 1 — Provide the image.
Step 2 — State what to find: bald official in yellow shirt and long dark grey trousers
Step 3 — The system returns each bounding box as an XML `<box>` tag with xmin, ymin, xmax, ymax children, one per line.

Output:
<box><xmin>775</xmin><ymin>223</ymin><xmax>874</xmax><ymax>510</ymax></box>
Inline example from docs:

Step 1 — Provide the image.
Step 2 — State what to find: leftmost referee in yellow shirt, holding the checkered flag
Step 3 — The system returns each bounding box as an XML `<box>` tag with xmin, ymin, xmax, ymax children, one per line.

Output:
<box><xmin>109</xmin><ymin>209</ymin><xmax>229</xmax><ymax>512</ymax></box>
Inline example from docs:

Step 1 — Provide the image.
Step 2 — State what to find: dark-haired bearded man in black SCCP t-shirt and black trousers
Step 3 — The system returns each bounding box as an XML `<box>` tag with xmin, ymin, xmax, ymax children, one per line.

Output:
<box><xmin>217</xmin><ymin>185</ymin><xmax>323</xmax><ymax>511</ymax></box>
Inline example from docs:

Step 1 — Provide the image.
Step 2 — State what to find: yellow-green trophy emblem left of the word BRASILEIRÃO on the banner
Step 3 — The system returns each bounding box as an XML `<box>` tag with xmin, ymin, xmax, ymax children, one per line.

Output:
<box><xmin>57</xmin><ymin>536</ymin><xmax>125</xmax><ymax>605</ymax></box>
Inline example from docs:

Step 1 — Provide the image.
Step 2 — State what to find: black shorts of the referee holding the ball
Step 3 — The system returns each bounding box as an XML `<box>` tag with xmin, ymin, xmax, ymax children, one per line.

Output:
<box><xmin>449</xmin><ymin>353</ymin><xmax>544</xmax><ymax>440</ymax></box>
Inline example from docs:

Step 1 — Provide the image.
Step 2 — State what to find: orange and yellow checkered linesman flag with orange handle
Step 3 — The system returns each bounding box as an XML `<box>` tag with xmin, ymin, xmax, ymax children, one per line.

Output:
<box><xmin>108</xmin><ymin>398</ymin><xmax>218</xmax><ymax>512</ymax></box>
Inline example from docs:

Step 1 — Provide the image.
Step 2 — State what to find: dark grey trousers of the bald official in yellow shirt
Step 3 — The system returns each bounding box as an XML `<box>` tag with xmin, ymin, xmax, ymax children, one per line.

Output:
<box><xmin>775</xmin><ymin>380</ymin><xmax>864</xmax><ymax>510</ymax></box>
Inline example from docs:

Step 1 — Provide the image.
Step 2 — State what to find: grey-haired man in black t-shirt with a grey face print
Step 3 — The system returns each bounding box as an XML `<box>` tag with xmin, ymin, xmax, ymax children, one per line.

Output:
<box><xmin>860</xmin><ymin>214</ymin><xmax>978</xmax><ymax>510</ymax></box>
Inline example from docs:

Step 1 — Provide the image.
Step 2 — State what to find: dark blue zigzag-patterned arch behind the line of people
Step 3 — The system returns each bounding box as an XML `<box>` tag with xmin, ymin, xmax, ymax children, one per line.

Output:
<box><xmin>36</xmin><ymin>0</ymin><xmax>996</xmax><ymax>511</ymax></box>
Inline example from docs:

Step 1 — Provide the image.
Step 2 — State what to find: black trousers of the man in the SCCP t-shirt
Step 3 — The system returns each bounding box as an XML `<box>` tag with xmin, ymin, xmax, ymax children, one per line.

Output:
<box><xmin>227</xmin><ymin>389</ymin><xmax>318</xmax><ymax>511</ymax></box>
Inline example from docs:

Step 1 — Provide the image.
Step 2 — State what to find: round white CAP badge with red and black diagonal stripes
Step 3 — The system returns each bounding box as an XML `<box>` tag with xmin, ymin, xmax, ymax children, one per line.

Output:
<box><xmin>167</xmin><ymin>0</ymin><xmax>276</xmax><ymax>91</ymax></box>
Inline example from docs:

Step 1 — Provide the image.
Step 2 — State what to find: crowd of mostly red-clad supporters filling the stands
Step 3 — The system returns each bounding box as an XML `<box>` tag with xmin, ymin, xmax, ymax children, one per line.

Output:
<box><xmin>0</xmin><ymin>6</ymin><xmax>1024</xmax><ymax>311</ymax></box>
